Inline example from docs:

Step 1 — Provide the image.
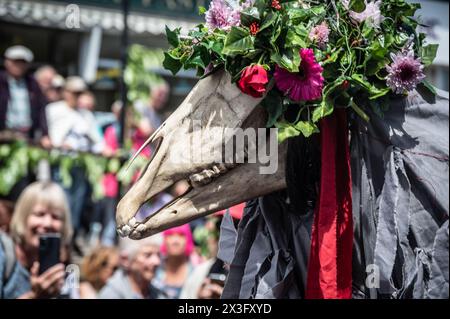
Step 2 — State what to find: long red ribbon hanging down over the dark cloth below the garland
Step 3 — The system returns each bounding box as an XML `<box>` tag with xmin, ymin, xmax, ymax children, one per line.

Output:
<box><xmin>306</xmin><ymin>109</ymin><xmax>353</xmax><ymax>299</ymax></box>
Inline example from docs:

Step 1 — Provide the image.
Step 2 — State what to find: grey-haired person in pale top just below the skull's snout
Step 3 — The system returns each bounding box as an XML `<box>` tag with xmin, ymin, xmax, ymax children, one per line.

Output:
<box><xmin>99</xmin><ymin>234</ymin><xmax>166</xmax><ymax>299</ymax></box>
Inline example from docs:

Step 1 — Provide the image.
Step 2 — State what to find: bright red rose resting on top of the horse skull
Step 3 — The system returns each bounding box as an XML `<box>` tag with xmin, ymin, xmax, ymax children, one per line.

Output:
<box><xmin>238</xmin><ymin>65</ymin><xmax>269</xmax><ymax>97</ymax></box>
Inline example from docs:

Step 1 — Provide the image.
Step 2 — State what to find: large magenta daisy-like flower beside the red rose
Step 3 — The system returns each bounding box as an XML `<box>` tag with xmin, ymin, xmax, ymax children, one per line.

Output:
<box><xmin>274</xmin><ymin>49</ymin><xmax>325</xmax><ymax>102</ymax></box>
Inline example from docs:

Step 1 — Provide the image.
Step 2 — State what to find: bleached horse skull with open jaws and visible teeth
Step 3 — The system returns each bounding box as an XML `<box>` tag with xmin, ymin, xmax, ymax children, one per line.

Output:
<box><xmin>116</xmin><ymin>72</ymin><xmax>286</xmax><ymax>239</ymax></box>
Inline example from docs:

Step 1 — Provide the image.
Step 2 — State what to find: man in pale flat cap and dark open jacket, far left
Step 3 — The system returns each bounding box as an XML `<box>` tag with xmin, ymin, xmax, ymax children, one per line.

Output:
<box><xmin>0</xmin><ymin>45</ymin><xmax>51</xmax><ymax>147</ymax></box>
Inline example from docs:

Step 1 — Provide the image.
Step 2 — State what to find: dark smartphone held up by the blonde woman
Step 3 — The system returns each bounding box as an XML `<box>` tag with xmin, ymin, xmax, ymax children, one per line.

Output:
<box><xmin>39</xmin><ymin>234</ymin><xmax>61</xmax><ymax>274</ymax></box>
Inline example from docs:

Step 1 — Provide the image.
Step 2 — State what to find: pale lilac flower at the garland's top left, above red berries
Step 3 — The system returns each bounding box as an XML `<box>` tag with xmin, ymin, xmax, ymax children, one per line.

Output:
<box><xmin>206</xmin><ymin>0</ymin><xmax>241</xmax><ymax>31</ymax></box>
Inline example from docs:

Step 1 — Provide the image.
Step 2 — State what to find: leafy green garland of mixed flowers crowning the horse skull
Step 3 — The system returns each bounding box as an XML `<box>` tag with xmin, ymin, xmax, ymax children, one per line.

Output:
<box><xmin>164</xmin><ymin>0</ymin><xmax>438</xmax><ymax>140</ymax></box>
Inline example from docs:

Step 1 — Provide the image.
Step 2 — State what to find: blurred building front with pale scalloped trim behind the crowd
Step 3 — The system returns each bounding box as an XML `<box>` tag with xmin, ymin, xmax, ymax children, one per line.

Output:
<box><xmin>0</xmin><ymin>0</ymin><xmax>204</xmax><ymax>111</ymax></box>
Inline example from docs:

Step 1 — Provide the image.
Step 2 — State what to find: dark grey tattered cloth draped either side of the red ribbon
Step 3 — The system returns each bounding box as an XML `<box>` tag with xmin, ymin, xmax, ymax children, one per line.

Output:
<box><xmin>219</xmin><ymin>91</ymin><xmax>449</xmax><ymax>298</ymax></box>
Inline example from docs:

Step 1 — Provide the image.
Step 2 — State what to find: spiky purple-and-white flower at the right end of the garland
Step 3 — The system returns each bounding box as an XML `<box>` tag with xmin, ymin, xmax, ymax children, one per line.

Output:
<box><xmin>386</xmin><ymin>50</ymin><xmax>425</xmax><ymax>94</ymax></box>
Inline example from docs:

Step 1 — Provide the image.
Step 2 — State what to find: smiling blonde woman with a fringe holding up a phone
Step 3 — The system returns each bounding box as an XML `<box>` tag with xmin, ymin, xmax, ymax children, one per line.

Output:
<box><xmin>0</xmin><ymin>182</ymin><xmax>72</xmax><ymax>298</ymax></box>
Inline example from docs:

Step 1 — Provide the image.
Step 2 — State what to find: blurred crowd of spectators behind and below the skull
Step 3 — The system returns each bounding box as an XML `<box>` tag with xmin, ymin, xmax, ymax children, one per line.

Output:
<box><xmin>0</xmin><ymin>46</ymin><xmax>239</xmax><ymax>299</ymax></box>
